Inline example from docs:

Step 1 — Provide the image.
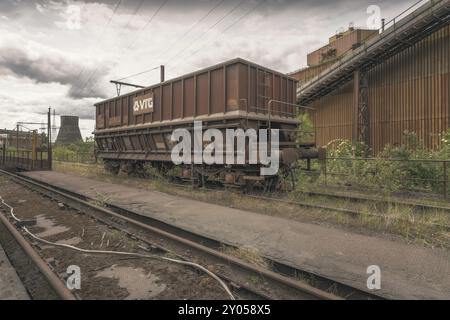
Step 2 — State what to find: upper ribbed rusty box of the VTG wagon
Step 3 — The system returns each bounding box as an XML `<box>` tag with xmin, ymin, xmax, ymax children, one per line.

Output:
<box><xmin>96</xmin><ymin>59</ymin><xmax>297</xmax><ymax>131</ymax></box>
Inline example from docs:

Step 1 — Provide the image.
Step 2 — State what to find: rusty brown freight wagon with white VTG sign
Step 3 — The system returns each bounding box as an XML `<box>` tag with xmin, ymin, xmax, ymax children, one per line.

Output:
<box><xmin>95</xmin><ymin>59</ymin><xmax>314</xmax><ymax>190</ymax></box>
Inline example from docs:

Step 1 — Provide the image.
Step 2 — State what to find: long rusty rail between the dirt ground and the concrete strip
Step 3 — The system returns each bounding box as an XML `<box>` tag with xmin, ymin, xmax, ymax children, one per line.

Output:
<box><xmin>0</xmin><ymin>170</ymin><xmax>383</xmax><ymax>300</ymax></box>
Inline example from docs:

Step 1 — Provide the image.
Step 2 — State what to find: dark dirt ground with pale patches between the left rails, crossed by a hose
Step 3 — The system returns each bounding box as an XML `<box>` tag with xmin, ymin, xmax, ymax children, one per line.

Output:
<box><xmin>0</xmin><ymin>177</ymin><xmax>232</xmax><ymax>299</ymax></box>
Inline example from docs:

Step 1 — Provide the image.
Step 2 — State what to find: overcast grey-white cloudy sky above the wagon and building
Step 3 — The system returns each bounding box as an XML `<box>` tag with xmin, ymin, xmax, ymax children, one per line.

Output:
<box><xmin>0</xmin><ymin>0</ymin><xmax>416</xmax><ymax>136</ymax></box>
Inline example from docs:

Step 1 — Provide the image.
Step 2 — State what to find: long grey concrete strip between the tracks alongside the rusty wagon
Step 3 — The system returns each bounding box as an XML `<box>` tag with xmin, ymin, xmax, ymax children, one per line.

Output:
<box><xmin>23</xmin><ymin>172</ymin><xmax>450</xmax><ymax>299</ymax></box>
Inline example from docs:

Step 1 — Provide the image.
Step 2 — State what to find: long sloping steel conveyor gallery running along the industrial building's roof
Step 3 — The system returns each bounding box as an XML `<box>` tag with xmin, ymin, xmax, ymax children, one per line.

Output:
<box><xmin>297</xmin><ymin>0</ymin><xmax>450</xmax><ymax>106</ymax></box>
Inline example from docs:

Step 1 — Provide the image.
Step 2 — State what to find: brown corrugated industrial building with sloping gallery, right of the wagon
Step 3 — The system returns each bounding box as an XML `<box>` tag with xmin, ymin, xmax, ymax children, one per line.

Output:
<box><xmin>290</xmin><ymin>0</ymin><xmax>450</xmax><ymax>154</ymax></box>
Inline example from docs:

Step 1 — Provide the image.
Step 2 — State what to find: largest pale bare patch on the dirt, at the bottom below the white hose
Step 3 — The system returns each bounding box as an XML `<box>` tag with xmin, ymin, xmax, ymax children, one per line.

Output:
<box><xmin>95</xmin><ymin>265</ymin><xmax>166</xmax><ymax>300</ymax></box>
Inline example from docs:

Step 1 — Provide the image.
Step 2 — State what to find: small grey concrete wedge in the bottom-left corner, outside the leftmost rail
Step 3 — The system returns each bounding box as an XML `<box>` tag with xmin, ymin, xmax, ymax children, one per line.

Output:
<box><xmin>0</xmin><ymin>246</ymin><xmax>30</xmax><ymax>300</ymax></box>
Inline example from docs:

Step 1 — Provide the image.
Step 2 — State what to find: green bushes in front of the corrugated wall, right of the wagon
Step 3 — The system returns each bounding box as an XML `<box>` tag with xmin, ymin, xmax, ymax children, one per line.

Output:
<box><xmin>298</xmin><ymin>131</ymin><xmax>450</xmax><ymax>194</ymax></box>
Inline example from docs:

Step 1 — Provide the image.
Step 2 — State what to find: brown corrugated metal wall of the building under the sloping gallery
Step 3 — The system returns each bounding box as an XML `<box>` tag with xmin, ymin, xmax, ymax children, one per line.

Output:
<box><xmin>306</xmin><ymin>26</ymin><xmax>450</xmax><ymax>153</ymax></box>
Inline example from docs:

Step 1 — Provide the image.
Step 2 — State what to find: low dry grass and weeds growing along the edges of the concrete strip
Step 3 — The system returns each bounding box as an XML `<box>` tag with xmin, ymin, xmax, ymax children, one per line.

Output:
<box><xmin>54</xmin><ymin>162</ymin><xmax>450</xmax><ymax>250</ymax></box>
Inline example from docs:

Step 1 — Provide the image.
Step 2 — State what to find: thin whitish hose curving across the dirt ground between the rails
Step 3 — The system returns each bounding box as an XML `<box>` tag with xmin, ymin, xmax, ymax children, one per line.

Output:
<box><xmin>0</xmin><ymin>195</ymin><xmax>235</xmax><ymax>300</ymax></box>
